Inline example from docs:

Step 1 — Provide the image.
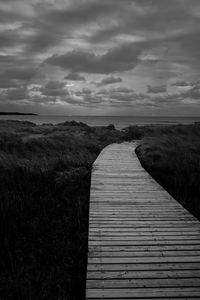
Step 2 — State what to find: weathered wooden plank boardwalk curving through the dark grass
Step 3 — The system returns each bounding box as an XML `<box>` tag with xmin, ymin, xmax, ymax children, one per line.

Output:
<box><xmin>86</xmin><ymin>143</ymin><xmax>200</xmax><ymax>300</ymax></box>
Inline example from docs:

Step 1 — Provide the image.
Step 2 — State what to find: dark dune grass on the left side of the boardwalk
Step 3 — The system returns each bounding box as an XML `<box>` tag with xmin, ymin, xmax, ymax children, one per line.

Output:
<box><xmin>0</xmin><ymin>121</ymin><xmax>122</xmax><ymax>300</ymax></box>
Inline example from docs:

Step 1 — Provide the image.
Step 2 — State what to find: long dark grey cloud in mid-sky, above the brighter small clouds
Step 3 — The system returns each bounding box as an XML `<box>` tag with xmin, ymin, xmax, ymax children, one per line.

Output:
<box><xmin>45</xmin><ymin>43</ymin><xmax>141</xmax><ymax>74</ymax></box>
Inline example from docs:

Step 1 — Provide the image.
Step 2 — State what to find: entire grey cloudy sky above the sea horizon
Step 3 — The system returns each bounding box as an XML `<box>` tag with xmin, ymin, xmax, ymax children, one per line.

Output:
<box><xmin>0</xmin><ymin>0</ymin><xmax>200</xmax><ymax>115</ymax></box>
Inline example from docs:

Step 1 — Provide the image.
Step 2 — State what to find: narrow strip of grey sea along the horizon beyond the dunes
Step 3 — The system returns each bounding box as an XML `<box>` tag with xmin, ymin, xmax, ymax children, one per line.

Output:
<box><xmin>0</xmin><ymin>115</ymin><xmax>200</xmax><ymax>129</ymax></box>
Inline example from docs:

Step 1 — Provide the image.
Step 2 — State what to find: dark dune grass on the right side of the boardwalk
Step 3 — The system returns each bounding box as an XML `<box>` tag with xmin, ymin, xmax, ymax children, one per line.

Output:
<box><xmin>136</xmin><ymin>125</ymin><xmax>200</xmax><ymax>220</ymax></box>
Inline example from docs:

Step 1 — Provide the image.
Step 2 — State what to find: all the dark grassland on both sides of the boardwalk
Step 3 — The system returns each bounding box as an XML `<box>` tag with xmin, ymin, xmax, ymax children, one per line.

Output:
<box><xmin>0</xmin><ymin>121</ymin><xmax>200</xmax><ymax>300</ymax></box>
